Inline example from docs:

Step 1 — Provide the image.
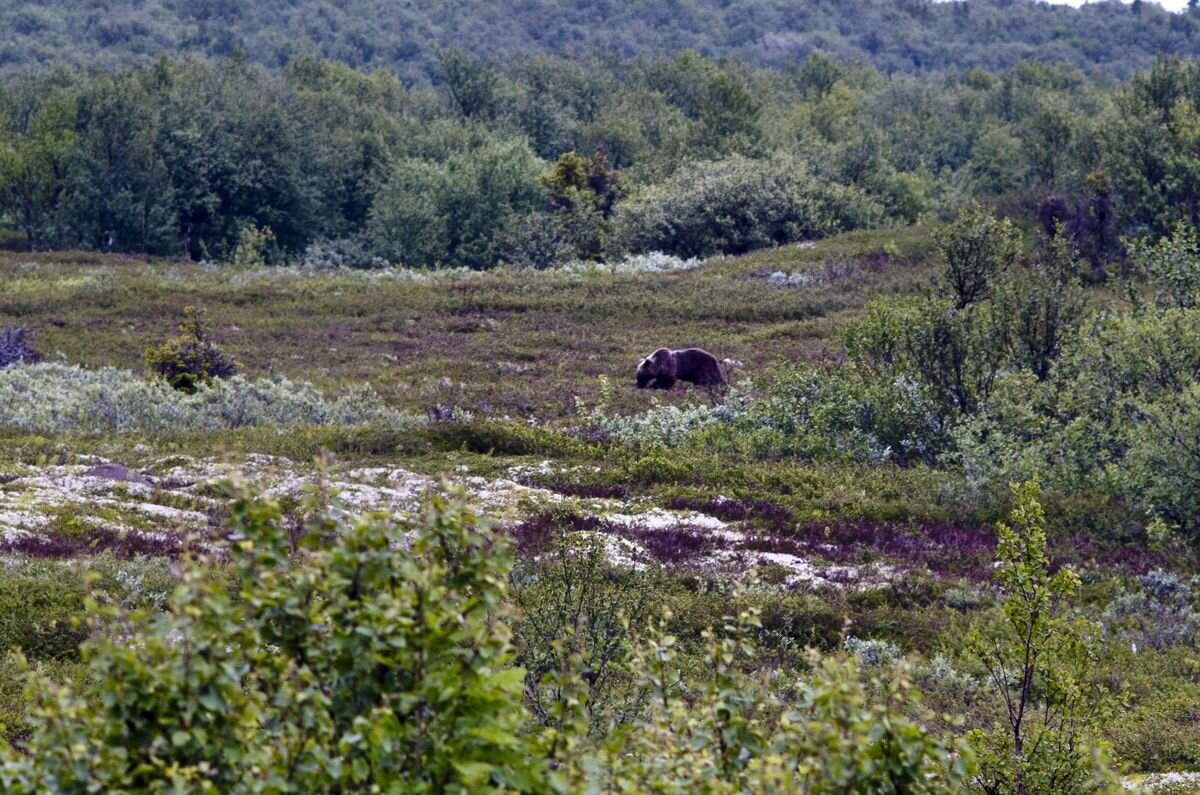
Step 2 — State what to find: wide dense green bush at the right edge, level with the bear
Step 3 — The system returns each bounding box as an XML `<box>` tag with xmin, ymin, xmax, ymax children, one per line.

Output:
<box><xmin>954</xmin><ymin>309</ymin><xmax>1200</xmax><ymax>534</ymax></box>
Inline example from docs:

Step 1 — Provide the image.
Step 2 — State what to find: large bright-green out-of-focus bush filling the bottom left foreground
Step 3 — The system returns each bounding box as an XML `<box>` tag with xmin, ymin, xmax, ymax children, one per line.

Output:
<box><xmin>0</xmin><ymin>489</ymin><xmax>528</xmax><ymax>793</ymax></box>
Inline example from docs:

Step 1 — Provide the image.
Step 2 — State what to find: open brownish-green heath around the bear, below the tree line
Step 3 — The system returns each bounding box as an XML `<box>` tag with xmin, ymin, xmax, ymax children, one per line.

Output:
<box><xmin>0</xmin><ymin>228</ymin><xmax>931</xmax><ymax>419</ymax></box>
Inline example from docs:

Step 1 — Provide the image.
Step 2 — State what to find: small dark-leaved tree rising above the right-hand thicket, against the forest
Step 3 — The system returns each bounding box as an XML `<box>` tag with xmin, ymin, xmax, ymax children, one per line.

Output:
<box><xmin>934</xmin><ymin>204</ymin><xmax>1021</xmax><ymax>309</ymax></box>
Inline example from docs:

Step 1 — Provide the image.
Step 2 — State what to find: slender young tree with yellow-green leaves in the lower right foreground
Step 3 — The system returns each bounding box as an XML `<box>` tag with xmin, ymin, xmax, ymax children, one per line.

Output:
<box><xmin>970</xmin><ymin>479</ymin><xmax>1115</xmax><ymax>795</ymax></box>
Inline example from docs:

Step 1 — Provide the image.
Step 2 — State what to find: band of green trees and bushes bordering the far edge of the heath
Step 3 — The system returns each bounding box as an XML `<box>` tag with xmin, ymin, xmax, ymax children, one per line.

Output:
<box><xmin>0</xmin><ymin>49</ymin><xmax>1200</xmax><ymax>275</ymax></box>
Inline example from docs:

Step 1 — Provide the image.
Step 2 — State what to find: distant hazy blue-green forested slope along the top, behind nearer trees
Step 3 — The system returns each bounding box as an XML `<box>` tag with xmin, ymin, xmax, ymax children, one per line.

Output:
<box><xmin>0</xmin><ymin>0</ymin><xmax>1198</xmax><ymax>83</ymax></box>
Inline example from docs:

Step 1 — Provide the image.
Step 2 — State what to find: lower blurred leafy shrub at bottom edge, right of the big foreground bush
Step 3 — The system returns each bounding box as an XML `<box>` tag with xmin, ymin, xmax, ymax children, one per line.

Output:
<box><xmin>602</xmin><ymin>610</ymin><xmax>971</xmax><ymax>795</ymax></box>
